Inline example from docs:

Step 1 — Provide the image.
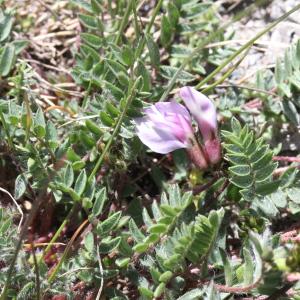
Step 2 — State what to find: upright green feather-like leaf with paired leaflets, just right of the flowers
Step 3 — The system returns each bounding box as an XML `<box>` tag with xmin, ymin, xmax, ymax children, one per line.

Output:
<box><xmin>222</xmin><ymin>118</ymin><xmax>277</xmax><ymax>201</ymax></box>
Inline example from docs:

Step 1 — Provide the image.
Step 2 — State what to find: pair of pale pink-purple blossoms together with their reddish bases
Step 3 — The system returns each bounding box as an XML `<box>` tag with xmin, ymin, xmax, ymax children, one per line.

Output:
<box><xmin>134</xmin><ymin>87</ymin><xmax>221</xmax><ymax>169</ymax></box>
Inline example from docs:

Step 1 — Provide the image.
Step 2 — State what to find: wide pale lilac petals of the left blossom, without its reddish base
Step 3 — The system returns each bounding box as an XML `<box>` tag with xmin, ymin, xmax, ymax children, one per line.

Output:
<box><xmin>134</xmin><ymin>102</ymin><xmax>194</xmax><ymax>154</ymax></box>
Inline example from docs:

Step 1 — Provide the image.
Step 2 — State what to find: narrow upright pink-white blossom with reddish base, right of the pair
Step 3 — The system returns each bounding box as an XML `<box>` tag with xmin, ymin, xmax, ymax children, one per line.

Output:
<box><xmin>179</xmin><ymin>86</ymin><xmax>221</xmax><ymax>164</ymax></box>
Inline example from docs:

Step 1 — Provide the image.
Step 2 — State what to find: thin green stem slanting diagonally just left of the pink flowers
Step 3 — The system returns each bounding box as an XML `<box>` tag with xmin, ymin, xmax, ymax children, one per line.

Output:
<box><xmin>88</xmin><ymin>78</ymin><xmax>140</xmax><ymax>181</ymax></box>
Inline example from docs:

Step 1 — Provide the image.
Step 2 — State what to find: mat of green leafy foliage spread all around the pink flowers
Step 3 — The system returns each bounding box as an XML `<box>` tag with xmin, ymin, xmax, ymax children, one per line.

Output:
<box><xmin>0</xmin><ymin>0</ymin><xmax>300</xmax><ymax>300</ymax></box>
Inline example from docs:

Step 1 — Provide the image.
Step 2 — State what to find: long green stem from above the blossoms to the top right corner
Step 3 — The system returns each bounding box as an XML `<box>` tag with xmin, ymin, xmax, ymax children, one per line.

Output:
<box><xmin>195</xmin><ymin>4</ymin><xmax>300</xmax><ymax>89</ymax></box>
